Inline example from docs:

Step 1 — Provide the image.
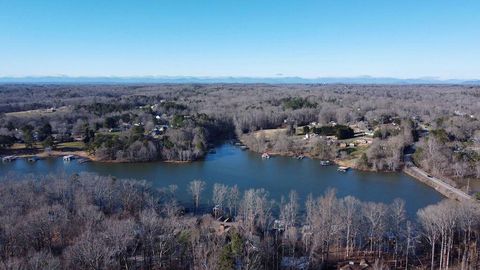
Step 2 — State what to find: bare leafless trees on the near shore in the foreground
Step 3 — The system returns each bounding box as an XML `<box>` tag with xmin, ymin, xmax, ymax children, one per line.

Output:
<box><xmin>0</xmin><ymin>174</ymin><xmax>480</xmax><ymax>270</ymax></box>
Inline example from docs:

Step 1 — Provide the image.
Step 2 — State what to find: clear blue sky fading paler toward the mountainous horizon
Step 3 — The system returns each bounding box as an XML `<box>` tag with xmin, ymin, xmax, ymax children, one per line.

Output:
<box><xmin>0</xmin><ymin>0</ymin><xmax>480</xmax><ymax>79</ymax></box>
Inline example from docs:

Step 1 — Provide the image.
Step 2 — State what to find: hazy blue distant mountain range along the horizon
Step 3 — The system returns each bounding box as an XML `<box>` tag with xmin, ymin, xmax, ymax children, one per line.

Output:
<box><xmin>0</xmin><ymin>76</ymin><xmax>480</xmax><ymax>85</ymax></box>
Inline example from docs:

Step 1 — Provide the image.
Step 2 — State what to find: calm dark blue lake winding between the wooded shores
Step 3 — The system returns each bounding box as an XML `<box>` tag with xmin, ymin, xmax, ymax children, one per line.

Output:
<box><xmin>0</xmin><ymin>144</ymin><xmax>443</xmax><ymax>215</ymax></box>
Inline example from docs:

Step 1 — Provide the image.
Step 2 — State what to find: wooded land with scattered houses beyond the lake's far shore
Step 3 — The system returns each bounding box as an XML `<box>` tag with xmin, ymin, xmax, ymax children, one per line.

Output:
<box><xmin>0</xmin><ymin>84</ymin><xmax>480</xmax><ymax>193</ymax></box>
